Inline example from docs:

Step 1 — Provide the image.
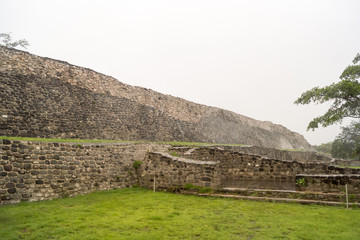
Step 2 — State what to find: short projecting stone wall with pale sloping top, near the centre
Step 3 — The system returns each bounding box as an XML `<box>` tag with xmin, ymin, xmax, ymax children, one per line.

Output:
<box><xmin>140</xmin><ymin>152</ymin><xmax>220</xmax><ymax>189</ymax></box>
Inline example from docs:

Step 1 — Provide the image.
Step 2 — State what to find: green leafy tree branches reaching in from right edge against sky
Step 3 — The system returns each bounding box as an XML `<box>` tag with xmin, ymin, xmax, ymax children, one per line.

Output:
<box><xmin>295</xmin><ymin>53</ymin><xmax>360</xmax><ymax>130</ymax></box>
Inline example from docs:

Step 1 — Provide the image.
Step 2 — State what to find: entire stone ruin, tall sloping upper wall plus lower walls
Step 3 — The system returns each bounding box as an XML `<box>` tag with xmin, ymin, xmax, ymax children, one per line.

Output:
<box><xmin>0</xmin><ymin>46</ymin><xmax>360</xmax><ymax>205</ymax></box>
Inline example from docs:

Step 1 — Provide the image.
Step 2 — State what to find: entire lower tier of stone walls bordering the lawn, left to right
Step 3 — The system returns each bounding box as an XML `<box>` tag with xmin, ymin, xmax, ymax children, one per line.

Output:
<box><xmin>0</xmin><ymin>139</ymin><xmax>360</xmax><ymax>205</ymax></box>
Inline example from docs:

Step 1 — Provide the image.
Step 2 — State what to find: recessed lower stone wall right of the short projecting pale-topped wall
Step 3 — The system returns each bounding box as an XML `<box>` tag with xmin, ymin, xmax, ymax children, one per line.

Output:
<box><xmin>167</xmin><ymin>147</ymin><xmax>360</xmax><ymax>190</ymax></box>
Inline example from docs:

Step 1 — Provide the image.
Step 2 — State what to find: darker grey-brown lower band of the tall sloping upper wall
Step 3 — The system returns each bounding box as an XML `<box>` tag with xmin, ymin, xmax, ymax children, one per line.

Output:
<box><xmin>0</xmin><ymin>72</ymin><xmax>199</xmax><ymax>141</ymax></box>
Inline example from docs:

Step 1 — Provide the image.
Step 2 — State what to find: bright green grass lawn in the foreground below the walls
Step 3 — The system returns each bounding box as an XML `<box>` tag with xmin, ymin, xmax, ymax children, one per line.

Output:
<box><xmin>0</xmin><ymin>189</ymin><xmax>360</xmax><ymax>240</ymax></box>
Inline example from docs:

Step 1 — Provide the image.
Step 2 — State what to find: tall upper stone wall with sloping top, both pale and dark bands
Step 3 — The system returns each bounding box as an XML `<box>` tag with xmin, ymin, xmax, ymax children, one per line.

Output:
<box><xmin>0</xmin><ymin>47</ymin><xmax>310</xmax><ymax>149</ymax></box>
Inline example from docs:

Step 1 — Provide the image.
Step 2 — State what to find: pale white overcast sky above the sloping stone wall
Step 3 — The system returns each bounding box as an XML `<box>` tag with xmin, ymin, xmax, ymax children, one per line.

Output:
<box><xmin>0</xmin><ymin>0</ymin><xmax>360</xmax><ymax>144</ymax></box>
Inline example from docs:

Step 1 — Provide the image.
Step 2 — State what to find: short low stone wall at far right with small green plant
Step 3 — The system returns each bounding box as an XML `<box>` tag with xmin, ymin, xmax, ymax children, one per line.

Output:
<box><xmin>296</xmin><ymin>174</ymin><xmax>360</xmax><ymax>194</ymax></box>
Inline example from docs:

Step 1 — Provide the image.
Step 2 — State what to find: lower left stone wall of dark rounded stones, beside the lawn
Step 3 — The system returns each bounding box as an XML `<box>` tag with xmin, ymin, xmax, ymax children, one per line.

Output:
<box><xmin>0</xmin><ymin>140</ymin><xmax>168</xmax><ymax>205</ymax></box>
